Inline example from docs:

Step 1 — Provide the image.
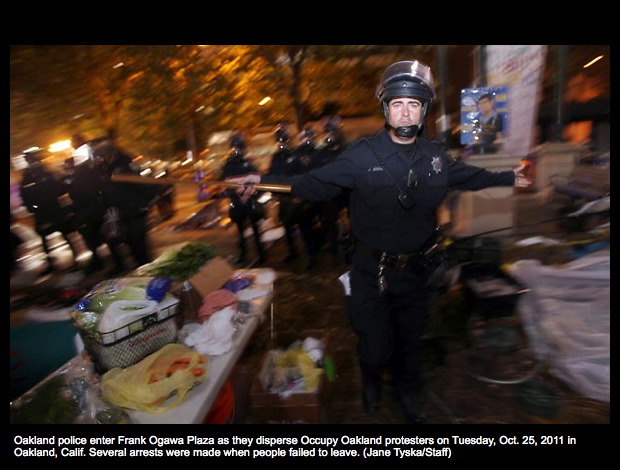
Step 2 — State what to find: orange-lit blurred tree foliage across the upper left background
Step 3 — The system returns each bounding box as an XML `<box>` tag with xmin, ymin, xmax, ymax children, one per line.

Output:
<box><xmin>10</xmin><ymin>45</ymin><xmax>432</xmax><ymax>158</ymax></box>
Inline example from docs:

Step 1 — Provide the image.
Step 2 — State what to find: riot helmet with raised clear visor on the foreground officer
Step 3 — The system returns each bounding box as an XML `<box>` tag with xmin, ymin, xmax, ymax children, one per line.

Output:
<box><xmin>375</xmin><ymin>60</ymin><xmax>436</xmax><ymax>137</ymax></box>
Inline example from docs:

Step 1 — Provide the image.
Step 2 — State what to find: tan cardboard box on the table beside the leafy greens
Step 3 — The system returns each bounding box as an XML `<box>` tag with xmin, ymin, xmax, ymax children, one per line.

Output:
<box><xmin>171</xmin><ymin>256</ymin><xmax>235</xmax><ymax>322</ymax></box>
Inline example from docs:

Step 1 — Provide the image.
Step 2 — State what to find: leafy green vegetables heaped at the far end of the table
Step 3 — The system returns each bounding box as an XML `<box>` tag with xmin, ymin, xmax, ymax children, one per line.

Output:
<box><xmin>149</xmin><ymin>241</ymin><xmax>217</xmax><ymax>281</ymax></box>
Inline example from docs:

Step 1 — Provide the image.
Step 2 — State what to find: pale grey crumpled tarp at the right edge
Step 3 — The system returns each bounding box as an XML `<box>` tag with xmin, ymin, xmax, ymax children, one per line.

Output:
<box><xmin>510</xmin><ymin>250</ymin><xmax>611</xmax><ymax>402</ymax></box>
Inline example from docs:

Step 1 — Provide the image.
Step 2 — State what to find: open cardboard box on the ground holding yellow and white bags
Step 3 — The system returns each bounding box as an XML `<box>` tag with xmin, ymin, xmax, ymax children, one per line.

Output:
<box><xmin>250</xmin><ymin>330</ymin><xmax>329</xmax><ymax>424</ymax></box>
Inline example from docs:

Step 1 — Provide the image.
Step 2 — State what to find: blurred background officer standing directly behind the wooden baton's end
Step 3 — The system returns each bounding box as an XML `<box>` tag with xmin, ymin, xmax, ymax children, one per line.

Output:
<box><xmin>221</xmin><ymin>132</ymin><xmax>266</xmax><ymax>264</ymax></box>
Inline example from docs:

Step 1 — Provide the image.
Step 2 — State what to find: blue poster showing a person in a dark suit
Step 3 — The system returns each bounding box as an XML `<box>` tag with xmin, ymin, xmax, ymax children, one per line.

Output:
<box><xmin>461</xmin><ymin>86</ymin><xmax>509</xmax><ymax>151</ymax></box>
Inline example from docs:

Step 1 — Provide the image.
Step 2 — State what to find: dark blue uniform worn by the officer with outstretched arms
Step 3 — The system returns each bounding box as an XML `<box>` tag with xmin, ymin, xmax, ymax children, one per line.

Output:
<box><xmin>262</xmin><ymin>126</ymin><xmax>515</xmax><ymax>414</ymax></box>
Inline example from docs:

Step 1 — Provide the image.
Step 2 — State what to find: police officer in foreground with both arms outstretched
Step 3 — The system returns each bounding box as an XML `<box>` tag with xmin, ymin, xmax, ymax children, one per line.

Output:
<box><xmin>228</xmin><ymin>60</ymin><xmax>524</xmax><ymax>423</ymax></box>
